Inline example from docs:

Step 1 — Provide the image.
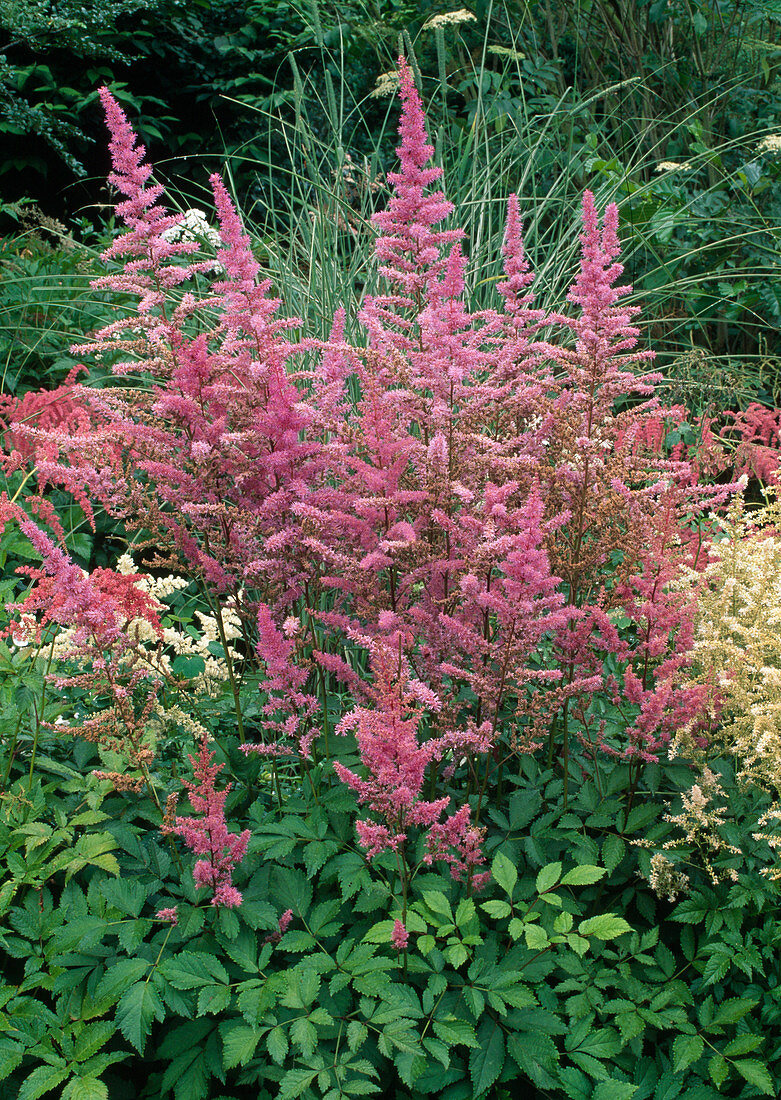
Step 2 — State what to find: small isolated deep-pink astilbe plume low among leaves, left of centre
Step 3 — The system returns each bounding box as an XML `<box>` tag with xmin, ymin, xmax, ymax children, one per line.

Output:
<box><xmin>173</xmin><ymin>737</ymin><xmax>250</xmax><ymax>909</ymax></box>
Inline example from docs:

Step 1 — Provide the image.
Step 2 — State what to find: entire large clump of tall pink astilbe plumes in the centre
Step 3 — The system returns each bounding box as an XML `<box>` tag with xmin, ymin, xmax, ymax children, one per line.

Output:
<box><xmin>0</xmin><ymin>59</ymin><xmax>739</xmax><ymax>906</ymax></box>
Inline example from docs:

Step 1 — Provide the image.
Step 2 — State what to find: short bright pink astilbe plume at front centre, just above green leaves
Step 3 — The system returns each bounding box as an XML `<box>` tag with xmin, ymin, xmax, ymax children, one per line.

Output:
<box><xmin>333</xmin><ymin>639</ymin><xmax>488</xmax><ymax>887</ymax></box>
